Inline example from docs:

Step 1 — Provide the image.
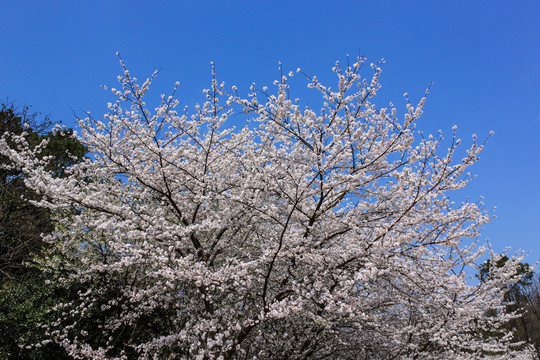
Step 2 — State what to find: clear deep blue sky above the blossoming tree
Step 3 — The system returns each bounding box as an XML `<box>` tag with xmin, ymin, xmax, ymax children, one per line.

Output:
<box><xmin>0</xmin><ymin>0</ymin><xmax>540</xmax><ymax>263</ymax></box>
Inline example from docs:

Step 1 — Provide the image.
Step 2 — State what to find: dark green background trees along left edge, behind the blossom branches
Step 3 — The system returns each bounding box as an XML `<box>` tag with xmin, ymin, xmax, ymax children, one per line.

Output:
<box><xmin>0</xmin><ymin>102</ymin><xmax>85</xmax><ymax>360</ymax></box>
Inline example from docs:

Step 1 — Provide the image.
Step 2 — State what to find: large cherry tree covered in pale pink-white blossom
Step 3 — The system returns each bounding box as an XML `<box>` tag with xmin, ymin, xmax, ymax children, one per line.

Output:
<box><xmin>0</xmin><ymin>59</ymin><xmax>527</xmax><ymax>359</ymax></box>
